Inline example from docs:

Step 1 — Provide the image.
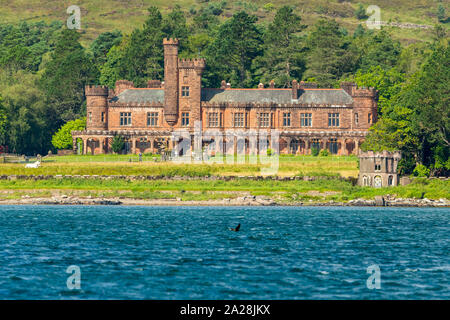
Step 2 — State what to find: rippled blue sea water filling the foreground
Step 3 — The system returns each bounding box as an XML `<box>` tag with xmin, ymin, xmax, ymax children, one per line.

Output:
<box><xmin>0</xmin><ymin>206</ymin><xmax>450</xmax><ymax>299</ymax></box>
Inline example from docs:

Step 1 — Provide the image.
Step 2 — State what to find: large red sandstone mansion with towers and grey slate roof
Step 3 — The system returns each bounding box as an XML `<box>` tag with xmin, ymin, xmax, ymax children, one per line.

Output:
<box><xmin>72</xmin><ymin>39</ymin><xmax>377</xmax><ymax>155</ymax></box>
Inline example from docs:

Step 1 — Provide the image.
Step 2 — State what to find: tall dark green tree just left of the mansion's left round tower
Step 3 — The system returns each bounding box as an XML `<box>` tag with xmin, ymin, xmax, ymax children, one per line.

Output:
<box><xmin>41</xmin><ymin>29</ymin><xmax>98</xmax><ymax>129</ymax></box>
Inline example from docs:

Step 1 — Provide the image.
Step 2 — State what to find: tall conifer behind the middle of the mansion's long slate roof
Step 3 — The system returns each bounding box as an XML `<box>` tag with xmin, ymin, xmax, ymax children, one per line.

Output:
<box><xmin>258</xmin><ymin>6</ymin><xmax>306</xmax><ymax>87</ymax></box>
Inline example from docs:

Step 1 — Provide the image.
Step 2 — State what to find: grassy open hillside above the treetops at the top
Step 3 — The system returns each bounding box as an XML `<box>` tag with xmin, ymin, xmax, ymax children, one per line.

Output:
<box><xmin>0</xmin><ymin>0</ymin><xmax>450</xmax><ymax>43</ymax></box>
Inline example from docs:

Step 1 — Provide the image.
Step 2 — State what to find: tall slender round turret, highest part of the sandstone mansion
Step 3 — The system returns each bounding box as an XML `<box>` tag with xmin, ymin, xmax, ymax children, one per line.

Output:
<box><xmin>163</xmin><ymin>38</ymin><xmax>178</xmax><ymax>126</ymax></box>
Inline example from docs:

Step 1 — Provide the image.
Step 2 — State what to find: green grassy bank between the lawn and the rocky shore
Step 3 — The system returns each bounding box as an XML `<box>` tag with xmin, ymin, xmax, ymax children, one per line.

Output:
<box><xmin>0</xmin><ymin>178</ymin><xmax>450</xmax><ymax>203</ymax></box>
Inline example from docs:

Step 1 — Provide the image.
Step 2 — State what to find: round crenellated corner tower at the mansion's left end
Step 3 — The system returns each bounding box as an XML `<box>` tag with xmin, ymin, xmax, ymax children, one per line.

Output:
<box><xmin>85</xmin><ymin>85</ymin><xmax>109</xmax><ymax>130</ymax></box>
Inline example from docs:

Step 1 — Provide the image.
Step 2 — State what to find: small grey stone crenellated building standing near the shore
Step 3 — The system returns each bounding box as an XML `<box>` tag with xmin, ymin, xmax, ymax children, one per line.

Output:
<box><xmin>358</xmin><ymin>151</ymin><xmax>401</xmax><ymax>188</ymax></box>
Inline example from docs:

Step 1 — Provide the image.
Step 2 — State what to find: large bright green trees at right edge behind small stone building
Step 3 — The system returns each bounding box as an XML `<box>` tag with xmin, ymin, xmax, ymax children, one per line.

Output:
<box><xmin>362</xmin><ymin>42</ymin><xmax>450</xmax><ymax>174</ymax></box>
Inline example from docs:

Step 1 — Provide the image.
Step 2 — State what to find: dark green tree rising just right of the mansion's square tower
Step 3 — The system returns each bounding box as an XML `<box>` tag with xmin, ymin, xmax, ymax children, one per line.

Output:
<box><xmin>206</xmin><ymin>11</ymin><xmax>262</xmax><ymax>87</ymax></box>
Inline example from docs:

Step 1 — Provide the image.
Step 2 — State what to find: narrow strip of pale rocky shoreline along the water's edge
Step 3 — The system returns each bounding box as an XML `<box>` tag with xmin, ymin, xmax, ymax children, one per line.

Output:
<box><xmin>0</xmin><ymin>195</ymin><xmax>450</xmax><ymax>207</ymax></box>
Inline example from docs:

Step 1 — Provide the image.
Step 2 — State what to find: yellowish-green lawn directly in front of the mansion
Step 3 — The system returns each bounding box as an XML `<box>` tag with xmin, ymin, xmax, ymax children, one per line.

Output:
<box><xmin>0</xmin><ymin>155</ymin><xmax>358</xmax><ymax>177</ymax></box>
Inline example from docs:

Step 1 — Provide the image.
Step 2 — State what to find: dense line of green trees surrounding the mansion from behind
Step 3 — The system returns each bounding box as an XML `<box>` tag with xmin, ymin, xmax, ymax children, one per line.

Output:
<box><xmin>0</xmin><ymin>5</ymin><xmax>450</xmax><ymax>174</ymax></box>
